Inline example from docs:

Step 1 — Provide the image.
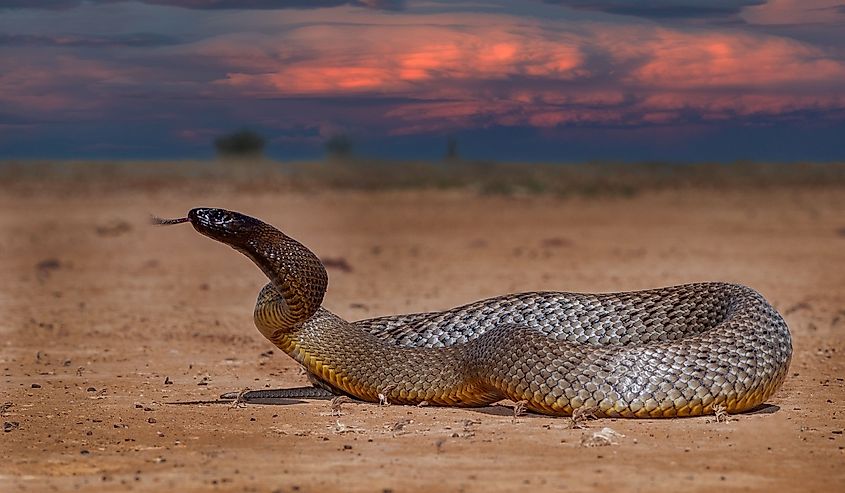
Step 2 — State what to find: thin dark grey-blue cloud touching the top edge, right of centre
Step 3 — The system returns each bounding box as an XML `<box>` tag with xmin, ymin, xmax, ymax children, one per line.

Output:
<box><xmin>544</xmin><ymin>0</ymin><xmax>766</xmax><ymax>19</ymax></box>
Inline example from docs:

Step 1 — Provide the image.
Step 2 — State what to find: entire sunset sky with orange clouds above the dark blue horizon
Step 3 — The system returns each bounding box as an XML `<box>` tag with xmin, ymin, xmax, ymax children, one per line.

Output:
<box><xmin>0</xmin><ymin>0</ymin><xmax>845</xmax><ymax>161</ymax></box>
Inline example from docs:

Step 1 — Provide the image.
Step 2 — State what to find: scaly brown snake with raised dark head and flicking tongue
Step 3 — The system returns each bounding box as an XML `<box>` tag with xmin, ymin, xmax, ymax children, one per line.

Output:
<box><xmin>158</xmin><ymin>208</ymin><xmax>792</xmax><ymax>418</ymax></box>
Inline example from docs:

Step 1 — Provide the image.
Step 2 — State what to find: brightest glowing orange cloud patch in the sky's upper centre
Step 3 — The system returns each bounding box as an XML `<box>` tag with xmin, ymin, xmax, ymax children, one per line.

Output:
<box><xmin>211</xmin><ymin>20</ymin><xmax>586</xmax><ymax>97</ymax></box>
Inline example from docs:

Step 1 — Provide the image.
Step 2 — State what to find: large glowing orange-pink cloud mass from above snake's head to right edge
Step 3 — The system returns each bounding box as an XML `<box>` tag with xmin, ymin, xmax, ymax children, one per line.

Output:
<box><xmin>200</xmin><ymin>9</ymin><xmax>845</xmax><ymax>133</ymax></box>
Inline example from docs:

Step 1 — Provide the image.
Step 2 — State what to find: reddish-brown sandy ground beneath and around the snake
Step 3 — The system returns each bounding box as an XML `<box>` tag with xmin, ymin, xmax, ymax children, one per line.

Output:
<box><xmin>0</xmin><ymin>176</ymin><xmax>845</xmax><ymax>492</ymax></box>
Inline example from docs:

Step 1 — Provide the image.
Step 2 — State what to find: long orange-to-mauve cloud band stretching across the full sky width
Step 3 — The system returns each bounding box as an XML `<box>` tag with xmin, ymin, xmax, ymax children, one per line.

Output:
<box><xmin>8</xmin><ymin>5</ymin><xmax>845</xmax><ymax>138</ymax></box>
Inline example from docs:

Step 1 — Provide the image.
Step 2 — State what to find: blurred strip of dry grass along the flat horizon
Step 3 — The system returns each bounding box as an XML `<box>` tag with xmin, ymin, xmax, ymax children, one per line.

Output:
<box><xmin>0</xmin><ymin>159</ymin><xmax>845</xmax><ymax>198</ymax></box>
